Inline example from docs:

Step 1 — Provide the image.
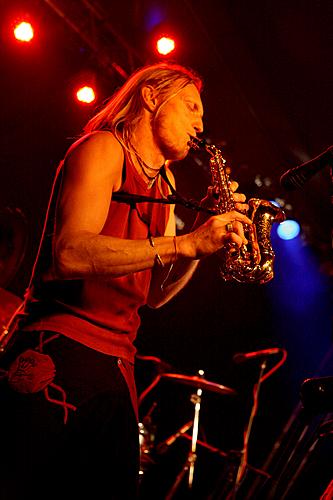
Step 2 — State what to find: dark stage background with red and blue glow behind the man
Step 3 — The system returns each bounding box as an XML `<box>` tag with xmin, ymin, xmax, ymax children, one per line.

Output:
<box><xmin>0</xmin><ymin>0</ymin><xmax>333</xmax><ymax>498</ymax></box>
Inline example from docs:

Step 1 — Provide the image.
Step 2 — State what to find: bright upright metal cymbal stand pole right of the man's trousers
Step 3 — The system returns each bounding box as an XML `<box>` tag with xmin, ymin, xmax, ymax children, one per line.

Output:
<box><xmin>165</xmin><ymin>370</ymin><xmax>204</xmax><ymax>500</ymax></box>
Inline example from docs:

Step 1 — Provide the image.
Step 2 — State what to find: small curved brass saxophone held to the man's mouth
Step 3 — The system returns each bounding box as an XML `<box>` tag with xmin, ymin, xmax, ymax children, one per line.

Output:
<box><xmin>189</xmin><ymin>138</ymin><xmax>286</xmax><ymax>284</ymax></box>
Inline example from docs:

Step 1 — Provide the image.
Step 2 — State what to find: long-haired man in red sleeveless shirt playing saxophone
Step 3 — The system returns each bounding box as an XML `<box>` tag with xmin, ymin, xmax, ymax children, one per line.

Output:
<box><xmin>1</xmin><ymin>63</ymin><xmax>251</xmax><ymax>500</ymax></box>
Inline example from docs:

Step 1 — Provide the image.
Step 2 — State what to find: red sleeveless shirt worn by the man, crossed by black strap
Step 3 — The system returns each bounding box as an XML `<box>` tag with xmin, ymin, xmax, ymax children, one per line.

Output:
<box><xmin>23</xmin><ymin>146</ymin><xmax>170</xmax><ymax>362</ymax></box>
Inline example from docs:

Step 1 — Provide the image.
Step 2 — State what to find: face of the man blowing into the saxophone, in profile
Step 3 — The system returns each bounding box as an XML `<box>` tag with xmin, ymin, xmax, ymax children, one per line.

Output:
<box><xmin>153</xmin><ymin>84</ymin><xmax>203</xmax><ymax>160</ymax></box>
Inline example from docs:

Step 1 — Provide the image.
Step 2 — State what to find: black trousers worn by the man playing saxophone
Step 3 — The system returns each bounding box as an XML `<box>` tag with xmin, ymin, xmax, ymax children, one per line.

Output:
<box><xmin>0</xmin><ymin>332</ymin><xmax>139</xmax><ymax>500</ymax></box>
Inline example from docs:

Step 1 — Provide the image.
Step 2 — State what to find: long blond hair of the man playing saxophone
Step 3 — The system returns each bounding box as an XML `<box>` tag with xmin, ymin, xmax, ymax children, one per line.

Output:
<box><xmin>84</xmin><ymin>63</ymin><xmax>203</xmax><ymax>149</ymax></box>
